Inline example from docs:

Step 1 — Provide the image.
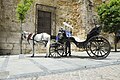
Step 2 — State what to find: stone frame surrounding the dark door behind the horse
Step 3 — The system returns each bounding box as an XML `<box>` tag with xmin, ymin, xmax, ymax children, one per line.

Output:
<box><xmin>35</xmin><ymin>4</ymin><xmax>56</xmax><ymax>35</ymax></box>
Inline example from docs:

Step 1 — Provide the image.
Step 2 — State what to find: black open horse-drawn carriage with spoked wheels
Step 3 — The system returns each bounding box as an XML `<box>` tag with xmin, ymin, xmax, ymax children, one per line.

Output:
<box><xmin>49</xmin><ymin>22</ymin><xmax>111</xmax><ymax>59</ymax></box>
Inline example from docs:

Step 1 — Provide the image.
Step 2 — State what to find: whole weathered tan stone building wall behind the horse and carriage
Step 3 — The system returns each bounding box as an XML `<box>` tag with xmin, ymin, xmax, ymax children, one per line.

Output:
<box><xmin>0</xmin><ymin>0</ymin><xmax>115</xmax><ymax>54</ymax></box>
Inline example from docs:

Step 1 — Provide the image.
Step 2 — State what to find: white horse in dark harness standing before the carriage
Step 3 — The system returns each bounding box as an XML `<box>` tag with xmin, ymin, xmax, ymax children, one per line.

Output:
<box><xmin>22</xmin><ymin>31</ymin><xmax>50</xmax><ymax>57</ymax></box>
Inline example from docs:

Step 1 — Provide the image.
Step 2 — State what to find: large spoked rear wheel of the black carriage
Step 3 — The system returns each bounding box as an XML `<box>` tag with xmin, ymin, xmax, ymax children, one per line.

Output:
<box><xmin>86</xmin><ymin>36</ymin><xmax>111</xmax><ymax>59</ymax></box>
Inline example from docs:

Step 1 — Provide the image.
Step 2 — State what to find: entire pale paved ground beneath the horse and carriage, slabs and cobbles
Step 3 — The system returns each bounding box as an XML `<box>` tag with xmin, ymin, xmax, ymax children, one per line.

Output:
<box><xmin>0</xmin><ymin>52</ymin><xmax>120</xmax><ymax>80</ymax></box>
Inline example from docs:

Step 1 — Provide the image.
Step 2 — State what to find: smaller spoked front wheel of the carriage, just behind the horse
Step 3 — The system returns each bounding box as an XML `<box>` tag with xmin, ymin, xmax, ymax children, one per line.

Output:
<box><xmin>49</xmin><ymin>45</ymin><xmax>64</xmax><ymax>58</ymax></box>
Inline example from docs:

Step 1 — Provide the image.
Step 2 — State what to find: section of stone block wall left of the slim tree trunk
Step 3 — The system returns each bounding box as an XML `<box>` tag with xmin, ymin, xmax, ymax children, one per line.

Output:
<box><xmin>0</xmin><ymin>0</ymin><xmax>20</xmax><ymax>54</ymax></box>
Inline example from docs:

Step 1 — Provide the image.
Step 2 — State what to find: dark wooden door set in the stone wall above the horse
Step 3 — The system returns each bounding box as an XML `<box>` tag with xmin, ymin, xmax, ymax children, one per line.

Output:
<box><xmin>37</xmin><ymin>10</ymin><xmax>51</xmax><ymax>35</ymax></box>
